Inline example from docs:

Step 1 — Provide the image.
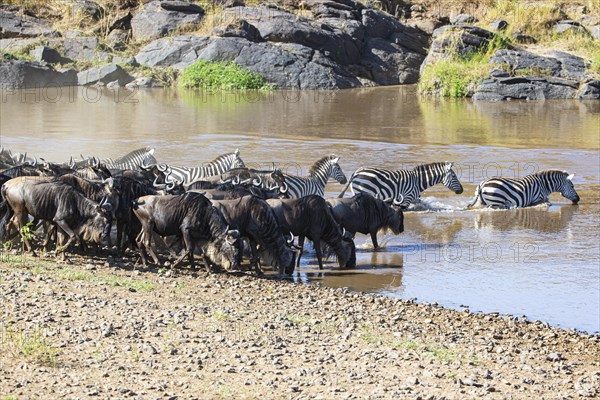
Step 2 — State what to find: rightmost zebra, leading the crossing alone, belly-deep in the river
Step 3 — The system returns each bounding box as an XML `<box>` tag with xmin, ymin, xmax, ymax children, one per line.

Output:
<box><xmin>469</xmin><ymin>170</ymin><xmax>579</xmax><ymax>208</ymax></box>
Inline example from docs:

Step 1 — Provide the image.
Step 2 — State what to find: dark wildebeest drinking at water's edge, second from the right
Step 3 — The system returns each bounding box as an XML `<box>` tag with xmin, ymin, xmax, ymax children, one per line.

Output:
<box><xmin>267</xmin><ymin>195</ymin><xmax>356</xmax><ymax>269</ymax></box>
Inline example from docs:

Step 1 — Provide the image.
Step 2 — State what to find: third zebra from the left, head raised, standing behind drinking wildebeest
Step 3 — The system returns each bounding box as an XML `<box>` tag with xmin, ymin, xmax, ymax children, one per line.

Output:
<box><xmin>279</xmin><ymin>154</ymin><xmax>347</xmax><ymax>199</ymax></box>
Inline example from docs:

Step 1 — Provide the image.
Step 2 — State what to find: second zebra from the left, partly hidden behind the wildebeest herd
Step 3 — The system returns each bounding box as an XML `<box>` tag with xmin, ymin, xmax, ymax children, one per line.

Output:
<box><xmin>157</xmin><ymin>149</ymin><xmax>245</xmax><ymax>187</ymax></box>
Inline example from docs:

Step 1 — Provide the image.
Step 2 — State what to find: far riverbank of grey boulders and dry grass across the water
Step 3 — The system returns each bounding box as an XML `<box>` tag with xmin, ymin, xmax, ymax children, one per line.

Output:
<box><xmin>0</xmin><ymin>0</ymin><xmax>600</xmax><ymax>100</ymax></box>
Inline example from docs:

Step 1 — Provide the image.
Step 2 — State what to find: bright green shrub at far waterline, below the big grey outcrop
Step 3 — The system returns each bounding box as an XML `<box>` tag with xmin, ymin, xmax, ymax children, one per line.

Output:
<box><xmin>179</xmin><ymin>60</ymin><xmax>273</xmax><ymax>90</ymax></box>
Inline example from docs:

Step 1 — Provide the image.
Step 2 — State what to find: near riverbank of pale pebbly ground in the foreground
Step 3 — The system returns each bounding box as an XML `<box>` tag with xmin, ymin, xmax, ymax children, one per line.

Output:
<box><xmin>0</xmin><ymin>256</ymin><xmax>600</xmax><ymax>399</ymax></box>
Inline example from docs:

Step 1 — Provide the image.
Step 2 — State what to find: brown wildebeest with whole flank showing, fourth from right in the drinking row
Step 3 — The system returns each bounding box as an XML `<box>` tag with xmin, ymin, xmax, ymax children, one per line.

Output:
<box><xmin>133</xmin><ymin>192</ymin><xmax>240</xmax><ymax>270</ymax></box>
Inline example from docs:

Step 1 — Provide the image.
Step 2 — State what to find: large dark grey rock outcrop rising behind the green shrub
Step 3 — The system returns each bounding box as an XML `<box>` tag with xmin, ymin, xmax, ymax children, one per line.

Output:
<box><xmin>136</xmin><ymin>0</ymin><xmax>428</xmax><ymax>89</ymax></box>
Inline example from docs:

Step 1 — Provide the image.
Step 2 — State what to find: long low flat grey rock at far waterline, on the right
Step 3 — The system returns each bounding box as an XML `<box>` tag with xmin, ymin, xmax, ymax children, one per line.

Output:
<box><xmin>473</xmin><ymin>76</ymin><xmax>579</xmax><ymax>101</ymax></box>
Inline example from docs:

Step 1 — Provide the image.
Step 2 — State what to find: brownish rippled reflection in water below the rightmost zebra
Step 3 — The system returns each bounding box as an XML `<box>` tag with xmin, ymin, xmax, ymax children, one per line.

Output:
<box><xmin>475</xmin><ymin>206</ymin><xmax>577</xmax><ymax>233</ymax></box>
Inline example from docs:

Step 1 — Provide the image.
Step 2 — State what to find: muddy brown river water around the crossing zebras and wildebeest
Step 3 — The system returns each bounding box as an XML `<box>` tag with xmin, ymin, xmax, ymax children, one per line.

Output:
<box><xmin>0</xmin><ymin>86</ymin><xmax>600</xmax><ymax>332</ymax></box>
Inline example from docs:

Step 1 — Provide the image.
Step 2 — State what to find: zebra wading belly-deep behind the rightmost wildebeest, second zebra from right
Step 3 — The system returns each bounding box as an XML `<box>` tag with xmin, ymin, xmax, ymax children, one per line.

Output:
<box><xmin>338</xmin><ymin>161</ymin><xmax>463</xmax><ymax>208</ymax></box>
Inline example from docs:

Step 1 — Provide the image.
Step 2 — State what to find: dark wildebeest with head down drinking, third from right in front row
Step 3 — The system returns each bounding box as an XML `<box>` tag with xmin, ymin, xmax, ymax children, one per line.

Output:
<box><xmin>213</xmin><ymin>196</ymin><xmax>294</xmax><ymax>274</ymax></box>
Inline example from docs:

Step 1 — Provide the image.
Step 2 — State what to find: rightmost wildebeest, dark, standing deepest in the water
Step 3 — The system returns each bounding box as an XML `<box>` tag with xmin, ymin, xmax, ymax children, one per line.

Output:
<box><xmin>326</xmin><ymin>193</ymin><xmax>404</xmax><ymax>248</ymax></box>
